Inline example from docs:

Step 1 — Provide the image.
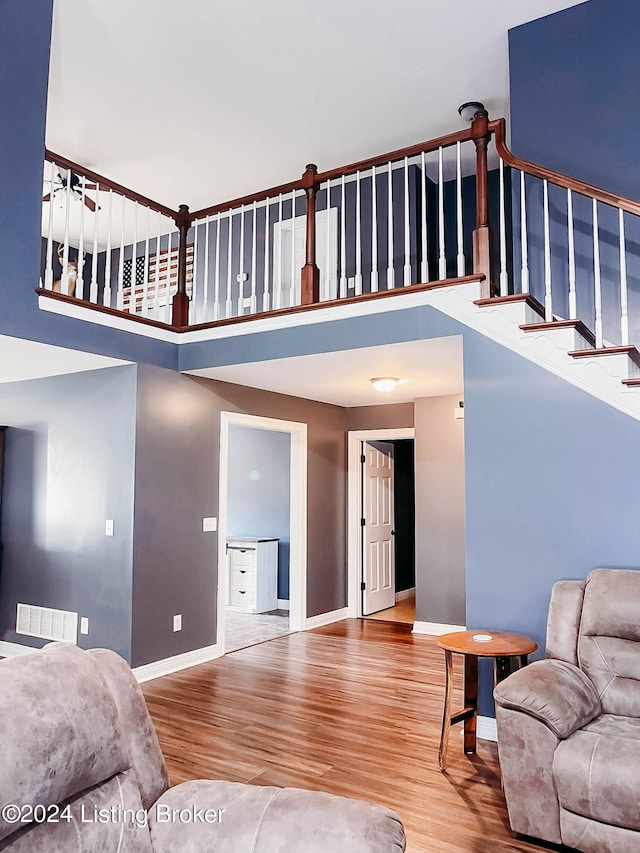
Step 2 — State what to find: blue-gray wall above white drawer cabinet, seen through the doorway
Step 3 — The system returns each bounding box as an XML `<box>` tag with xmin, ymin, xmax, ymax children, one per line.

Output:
<box><xmin>227</xmin><ymin>424</ymin><xmax>291</xmax><ymax>599</ymax></box>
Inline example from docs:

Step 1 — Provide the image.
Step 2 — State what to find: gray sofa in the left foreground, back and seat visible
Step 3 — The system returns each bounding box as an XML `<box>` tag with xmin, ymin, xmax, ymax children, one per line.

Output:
<box><xmin>0</xmin><ymin>644</ymin><xmax>405</xmax><ymax>853</ymax></box>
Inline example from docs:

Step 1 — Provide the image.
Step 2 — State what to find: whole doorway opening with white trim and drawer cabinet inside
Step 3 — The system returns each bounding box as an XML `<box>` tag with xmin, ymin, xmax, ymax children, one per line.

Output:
<box><xmin>217</xmin><ymin>412</ymin><xmax>307</xmax><ymax>654</ymax></box>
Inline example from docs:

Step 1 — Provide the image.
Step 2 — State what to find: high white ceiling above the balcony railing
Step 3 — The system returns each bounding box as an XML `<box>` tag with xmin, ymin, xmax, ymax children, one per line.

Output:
<box><xmin>47</xmin><ymin>0</ymin><xmax>582</xmax><ymax>210</ymax></box>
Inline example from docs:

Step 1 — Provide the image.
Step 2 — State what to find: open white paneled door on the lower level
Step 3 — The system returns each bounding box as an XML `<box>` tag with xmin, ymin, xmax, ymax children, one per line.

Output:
<box><xmin>362</xmin><ymin>441</ymin><xmax>396</xmax><ymax>616</ymax></box>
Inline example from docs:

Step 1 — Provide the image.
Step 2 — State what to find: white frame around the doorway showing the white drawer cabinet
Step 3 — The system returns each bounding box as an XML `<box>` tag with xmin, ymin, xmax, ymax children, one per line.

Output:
<box><xmin>216</xmin><ymin>412</ymin><xmax>307</xmax><ymax>654</ymax></box>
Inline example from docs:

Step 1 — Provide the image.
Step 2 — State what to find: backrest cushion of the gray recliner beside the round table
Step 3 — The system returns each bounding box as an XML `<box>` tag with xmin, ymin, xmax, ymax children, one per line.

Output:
<box><xmin>578</xmin><ymin>569</ymin><xmax>640</xmax><ymax>716</ymax></box>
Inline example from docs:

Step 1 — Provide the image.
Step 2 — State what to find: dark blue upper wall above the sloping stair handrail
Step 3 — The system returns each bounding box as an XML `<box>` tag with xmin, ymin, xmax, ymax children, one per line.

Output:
<box><xmin>509</xmin><ymin>0</ymin><xmax>640</xmax><ymax>200</ymax></box>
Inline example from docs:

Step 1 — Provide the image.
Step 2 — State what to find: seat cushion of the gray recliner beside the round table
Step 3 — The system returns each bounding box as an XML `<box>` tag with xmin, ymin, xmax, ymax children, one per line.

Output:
<box><xmin>553</xmin><ymin>714</ymin><xmax>640</xmax><ymax>832</ymax></box>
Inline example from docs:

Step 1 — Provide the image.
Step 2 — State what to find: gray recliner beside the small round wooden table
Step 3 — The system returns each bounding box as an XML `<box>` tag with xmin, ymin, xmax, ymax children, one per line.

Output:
<box><xmin>494</xmin><ymin>569</ymin><xmax>640</xmax><ymax>853</ymax></box>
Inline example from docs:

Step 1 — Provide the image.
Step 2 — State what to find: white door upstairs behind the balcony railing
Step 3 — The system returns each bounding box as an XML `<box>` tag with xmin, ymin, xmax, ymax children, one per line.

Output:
<box><xmin>273</xmin><ymin>207</ymin><xmax>338</xmax><ymax>308</ymax></box>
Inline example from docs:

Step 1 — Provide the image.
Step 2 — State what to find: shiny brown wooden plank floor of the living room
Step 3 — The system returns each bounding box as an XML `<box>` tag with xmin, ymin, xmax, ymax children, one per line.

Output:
<box><xmin>143</xmin><ymin>619</ymin><xmax>564</xmax><ymax>853</ymax></box>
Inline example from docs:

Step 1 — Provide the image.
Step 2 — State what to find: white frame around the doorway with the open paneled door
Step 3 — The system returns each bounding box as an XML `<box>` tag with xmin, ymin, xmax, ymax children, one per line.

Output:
<box><xmin>347</xmin><ymin>427</ymin><xmax>416</xmax><ymax>619</ymax></box>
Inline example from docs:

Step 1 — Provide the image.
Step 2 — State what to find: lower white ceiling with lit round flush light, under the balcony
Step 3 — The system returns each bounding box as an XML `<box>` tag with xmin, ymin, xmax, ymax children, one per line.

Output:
<box><xmin>190</xmin><ymin>337</ymin><xmax>463</xmax><ymax>407</ymax></box>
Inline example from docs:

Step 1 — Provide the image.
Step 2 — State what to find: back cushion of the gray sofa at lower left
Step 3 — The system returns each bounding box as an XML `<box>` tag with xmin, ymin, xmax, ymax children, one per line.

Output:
<box><xmin>0</xmin><ymin>644</ymin><xmax>129</xmax><ymax>840</ymax></box>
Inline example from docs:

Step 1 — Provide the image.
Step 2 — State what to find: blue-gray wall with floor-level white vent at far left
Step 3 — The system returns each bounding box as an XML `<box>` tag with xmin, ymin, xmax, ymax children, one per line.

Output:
<box><xmin>0</xmin><ymin>366</ymin><xmax>136</xmax><ymax>660</ymax></box>
